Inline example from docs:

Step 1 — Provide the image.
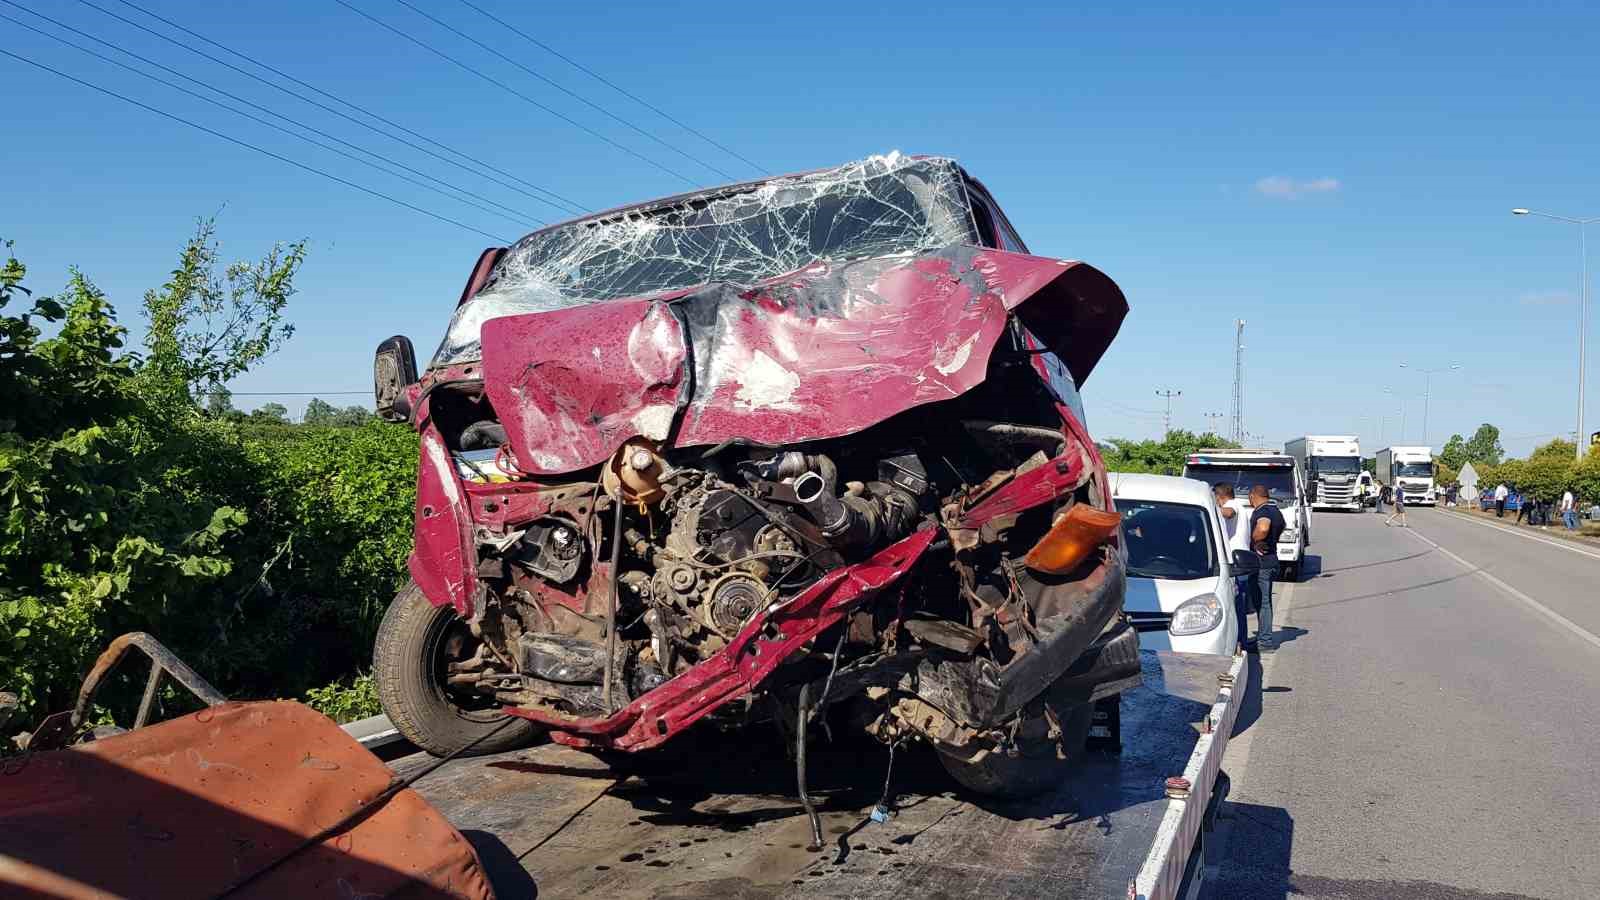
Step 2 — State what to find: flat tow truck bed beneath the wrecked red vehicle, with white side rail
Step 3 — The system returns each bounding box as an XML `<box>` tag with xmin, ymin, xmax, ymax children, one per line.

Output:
<box><xmin>390</xmin><ymin>652</ymin><xmax>1248</xmax><ymax>900</ymax></box>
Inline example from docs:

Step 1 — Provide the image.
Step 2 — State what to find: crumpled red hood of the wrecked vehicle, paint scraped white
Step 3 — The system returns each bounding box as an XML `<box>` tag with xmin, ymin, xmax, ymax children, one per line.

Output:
<box><xmin>482</xmin><ymin>247</ymin><xmax>1128</xmax><ymax>476</ymax></box>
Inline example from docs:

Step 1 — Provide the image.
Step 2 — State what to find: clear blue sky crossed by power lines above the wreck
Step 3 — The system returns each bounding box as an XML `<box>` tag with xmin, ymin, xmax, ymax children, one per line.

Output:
<box><xmin>0</xmin><ymin>0</ymin><xmax>1600</xmax><ymax>453</ymax></box>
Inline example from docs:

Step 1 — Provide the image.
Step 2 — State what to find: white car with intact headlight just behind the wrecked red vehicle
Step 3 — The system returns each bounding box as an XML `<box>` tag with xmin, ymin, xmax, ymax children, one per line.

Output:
<box><xmin>1110</xmin><ymin>472</ymin><xmax>1240</xmax><ymax>655</ymax></box>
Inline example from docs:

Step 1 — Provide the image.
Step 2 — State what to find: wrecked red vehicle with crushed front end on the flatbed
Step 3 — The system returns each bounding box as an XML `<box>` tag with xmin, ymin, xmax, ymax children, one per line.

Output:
<box><xmin>374</xmin><ymin>154</ymin><xmax>1139</xmax><ymax>794</ymax></box>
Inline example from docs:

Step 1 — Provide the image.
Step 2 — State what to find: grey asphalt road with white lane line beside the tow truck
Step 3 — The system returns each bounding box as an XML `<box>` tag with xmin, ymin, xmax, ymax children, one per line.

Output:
<box><xmin>1205</xmin><ymin>508</ymin><xmax>1600</xmax><ymax>900</ymax></box>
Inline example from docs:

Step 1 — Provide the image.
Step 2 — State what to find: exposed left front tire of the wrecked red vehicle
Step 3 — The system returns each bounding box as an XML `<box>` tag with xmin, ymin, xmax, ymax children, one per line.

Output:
<box><xmin>373</xmin><ymin>583</ymin><xmax>539</xmax><ymax>756</ymax></box>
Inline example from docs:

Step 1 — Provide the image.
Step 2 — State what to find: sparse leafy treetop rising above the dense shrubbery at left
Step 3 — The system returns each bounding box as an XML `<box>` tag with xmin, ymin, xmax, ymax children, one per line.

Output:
<box><xmin>144</xmin><ymin>219</ymin><xmax>306</xmax><ymax>394</ymax></box>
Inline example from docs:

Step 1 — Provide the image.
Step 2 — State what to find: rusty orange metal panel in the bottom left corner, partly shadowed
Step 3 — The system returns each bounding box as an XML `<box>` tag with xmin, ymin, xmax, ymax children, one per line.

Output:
<box><xmin>0</xmin><ymin>701</ymin><xmax>493</xmax><ymax>898</ymax></box>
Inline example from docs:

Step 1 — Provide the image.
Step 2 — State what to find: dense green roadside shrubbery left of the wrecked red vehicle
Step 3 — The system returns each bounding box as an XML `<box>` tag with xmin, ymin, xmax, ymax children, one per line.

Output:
<box><xmin>0</xmin><ymin>229</ymin><xmax>416</xmax><ymax>743</ymax></box>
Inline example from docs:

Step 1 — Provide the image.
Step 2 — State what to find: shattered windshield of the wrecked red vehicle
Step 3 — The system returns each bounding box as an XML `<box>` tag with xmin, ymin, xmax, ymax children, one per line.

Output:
<box><xmin>434</xmin><ymin>154</ymin><xmax>974</xmax><ymax>367</ymax></box>
